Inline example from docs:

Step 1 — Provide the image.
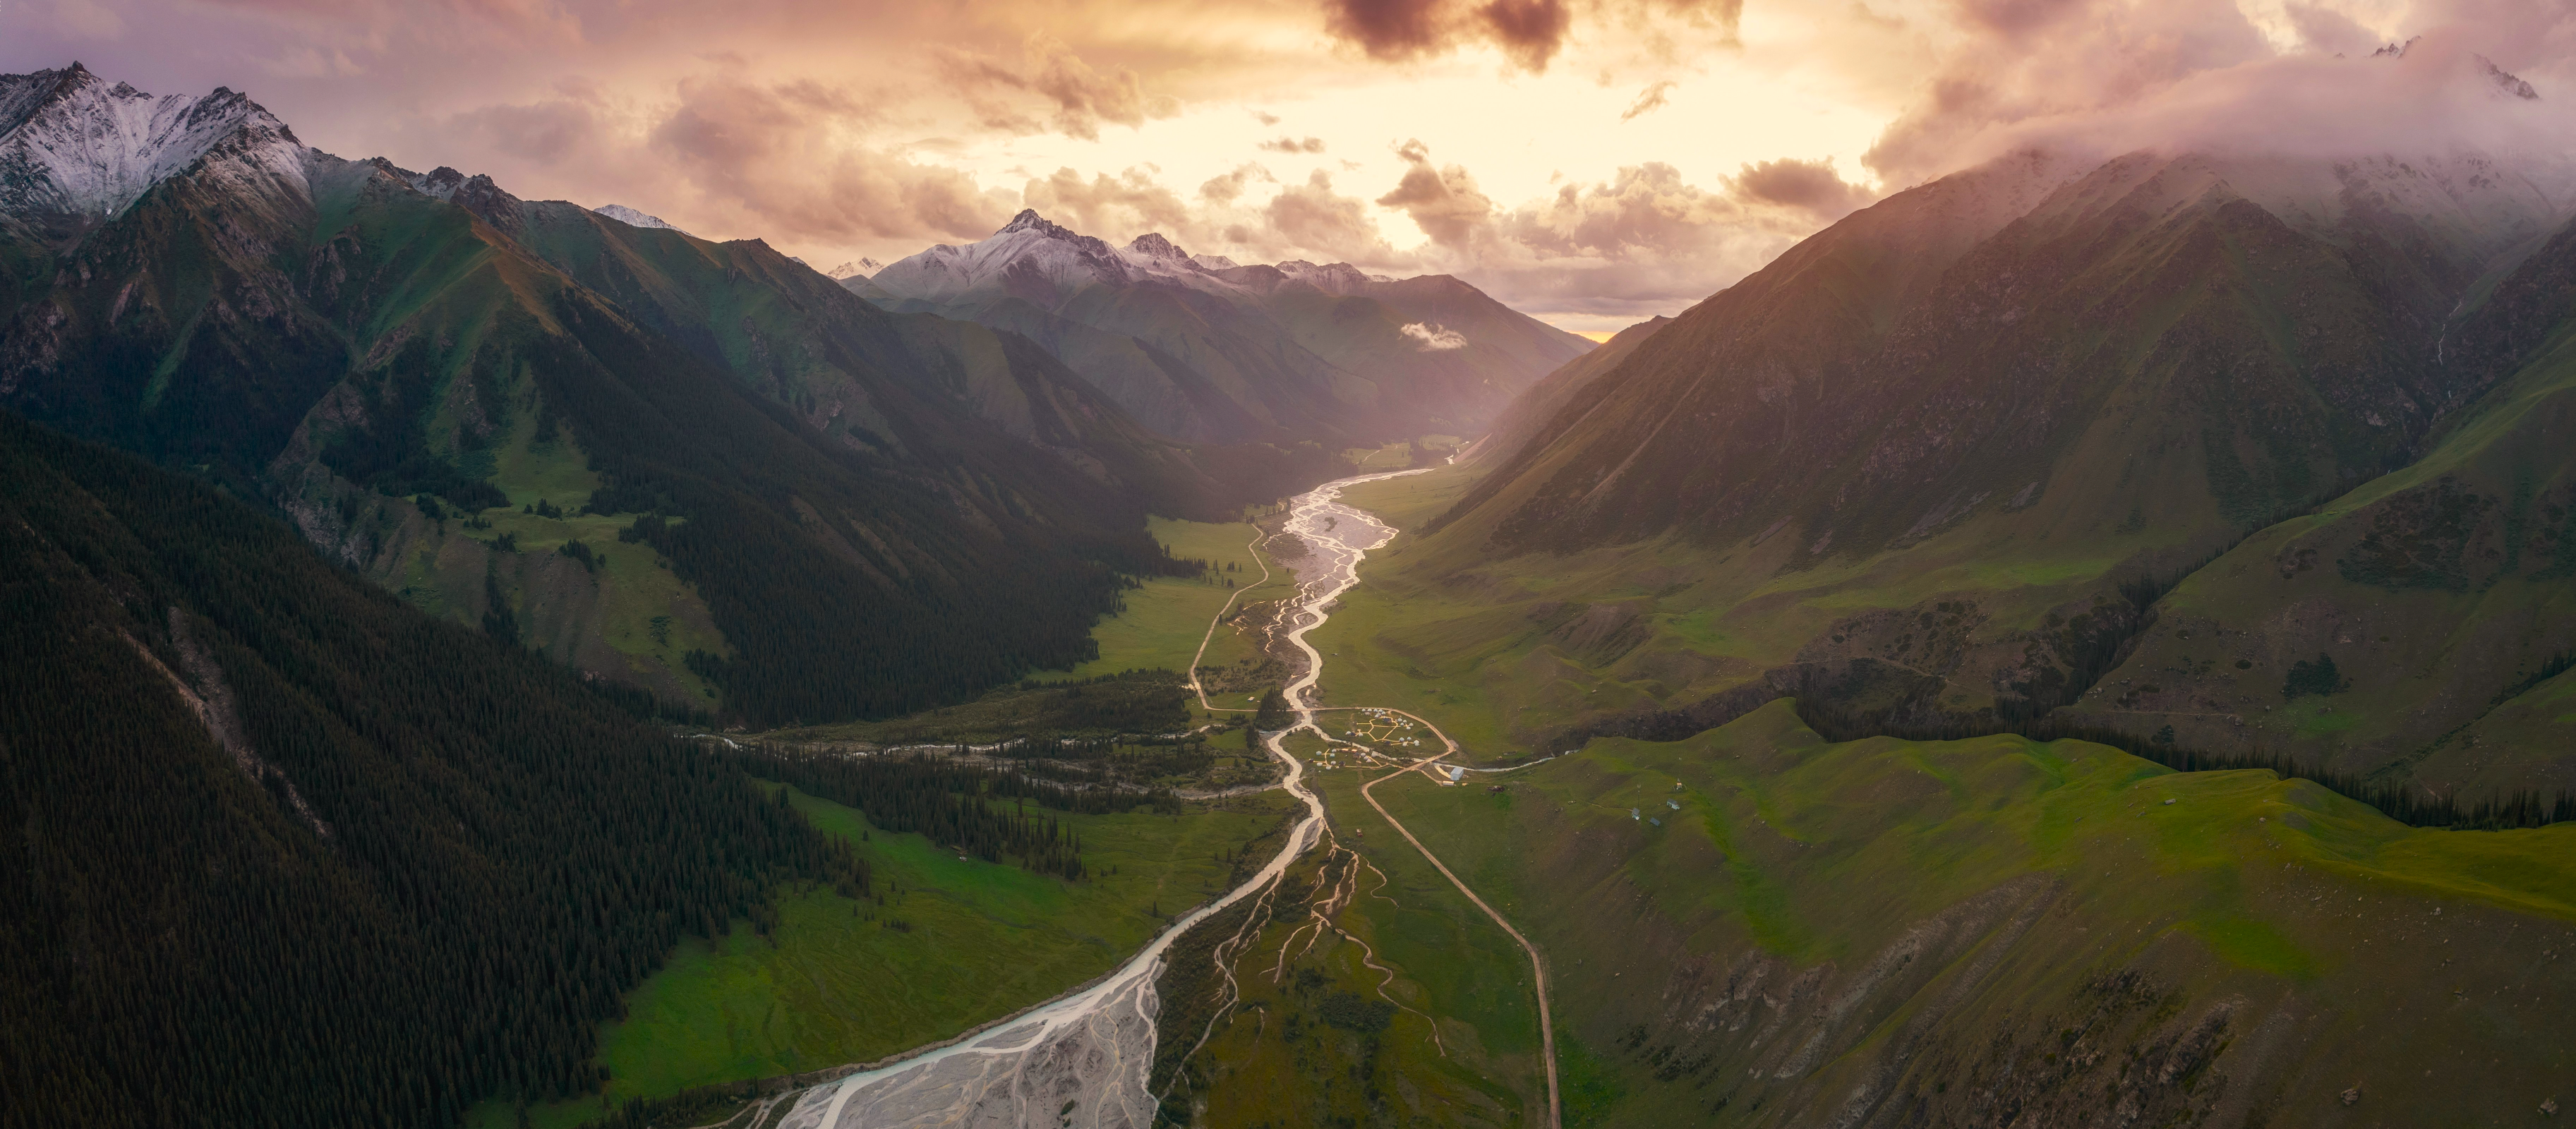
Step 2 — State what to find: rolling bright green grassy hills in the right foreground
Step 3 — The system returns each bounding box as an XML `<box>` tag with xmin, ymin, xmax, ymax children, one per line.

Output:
<box><xmin>1335</xmin><ymin>701</ymin><xmax>2576</xmax><ymax>1124</ymax></box>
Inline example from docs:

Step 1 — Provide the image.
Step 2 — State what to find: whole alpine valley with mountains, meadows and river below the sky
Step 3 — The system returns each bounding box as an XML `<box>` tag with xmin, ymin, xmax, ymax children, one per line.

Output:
<box><xmin>0</xmin><ymin>32</ymin><xmax>2576</xmax><ymax>1129</ymax></box>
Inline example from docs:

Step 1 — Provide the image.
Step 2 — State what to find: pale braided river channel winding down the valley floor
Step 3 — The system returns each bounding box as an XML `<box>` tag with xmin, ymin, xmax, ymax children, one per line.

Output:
<box><xmin>778</xmin><ymin>469</ymin><xmax>1419</xmax><ymax>1129</ymax></box>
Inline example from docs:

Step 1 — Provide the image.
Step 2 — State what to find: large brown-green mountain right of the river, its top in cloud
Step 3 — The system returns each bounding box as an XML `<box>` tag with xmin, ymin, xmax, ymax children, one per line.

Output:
<box><xmin>1430</xmin><ymin>139</ymin><xmax>2568</xmax><ymax>757</ymax></box>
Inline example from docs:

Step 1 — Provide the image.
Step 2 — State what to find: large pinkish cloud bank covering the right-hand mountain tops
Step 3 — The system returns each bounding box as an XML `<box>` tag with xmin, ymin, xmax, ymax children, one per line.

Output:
<box><xmin>1862</xmin><ymin>0</ymin><xmax>2576</xmax><ymax>186</ymax></box>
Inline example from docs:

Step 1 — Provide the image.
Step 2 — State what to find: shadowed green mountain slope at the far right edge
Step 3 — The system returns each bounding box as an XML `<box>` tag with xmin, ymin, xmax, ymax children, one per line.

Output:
<box><xmin>2076</xmin><ymin>211</ymin><xmax>2576</xmax><ymax>797</ymax></box>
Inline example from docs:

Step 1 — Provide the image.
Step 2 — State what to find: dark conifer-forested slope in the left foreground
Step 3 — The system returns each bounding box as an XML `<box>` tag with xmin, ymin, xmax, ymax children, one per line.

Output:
<box><xmin>0</xmin><ymin>412</ymin><xmax>865</xmax><ymax>1126</ymax></box>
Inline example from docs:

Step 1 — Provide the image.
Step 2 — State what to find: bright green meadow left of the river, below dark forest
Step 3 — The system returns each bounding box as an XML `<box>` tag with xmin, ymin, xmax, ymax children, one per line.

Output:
<box><xmin>469</xmin><ymin>789</ymin><xmax>1296</xmax><ymax>1126</ymax></box>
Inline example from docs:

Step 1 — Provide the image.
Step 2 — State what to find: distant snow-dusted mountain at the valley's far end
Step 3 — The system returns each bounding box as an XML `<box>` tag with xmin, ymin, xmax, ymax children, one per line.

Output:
<box><xmin>865</xmin><ymin>212</ymin><xmax>1592</xmax><ymax>449</ymax></box>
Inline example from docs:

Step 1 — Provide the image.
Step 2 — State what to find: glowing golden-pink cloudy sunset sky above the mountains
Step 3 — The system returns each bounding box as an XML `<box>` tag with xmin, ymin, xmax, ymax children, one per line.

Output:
<box><xmin>0</xmin><ymin>0</ymin><xmax>2576</xmax><ymax>335</ymax></box>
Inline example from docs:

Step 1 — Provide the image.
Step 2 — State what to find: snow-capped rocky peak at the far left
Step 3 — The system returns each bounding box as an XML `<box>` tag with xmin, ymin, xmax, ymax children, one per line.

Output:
<box><xmin>0</xmin><ymin>62</ymin><xmax>312</xmax><ymax>222</ymax></box>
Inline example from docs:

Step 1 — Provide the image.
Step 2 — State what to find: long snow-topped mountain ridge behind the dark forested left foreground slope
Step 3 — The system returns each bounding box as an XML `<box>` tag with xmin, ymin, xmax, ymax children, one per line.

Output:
<box><xmin>0</xmin><ymin>67</ymin><xmax>1293</xmax><ymax>722</ymax></box>
